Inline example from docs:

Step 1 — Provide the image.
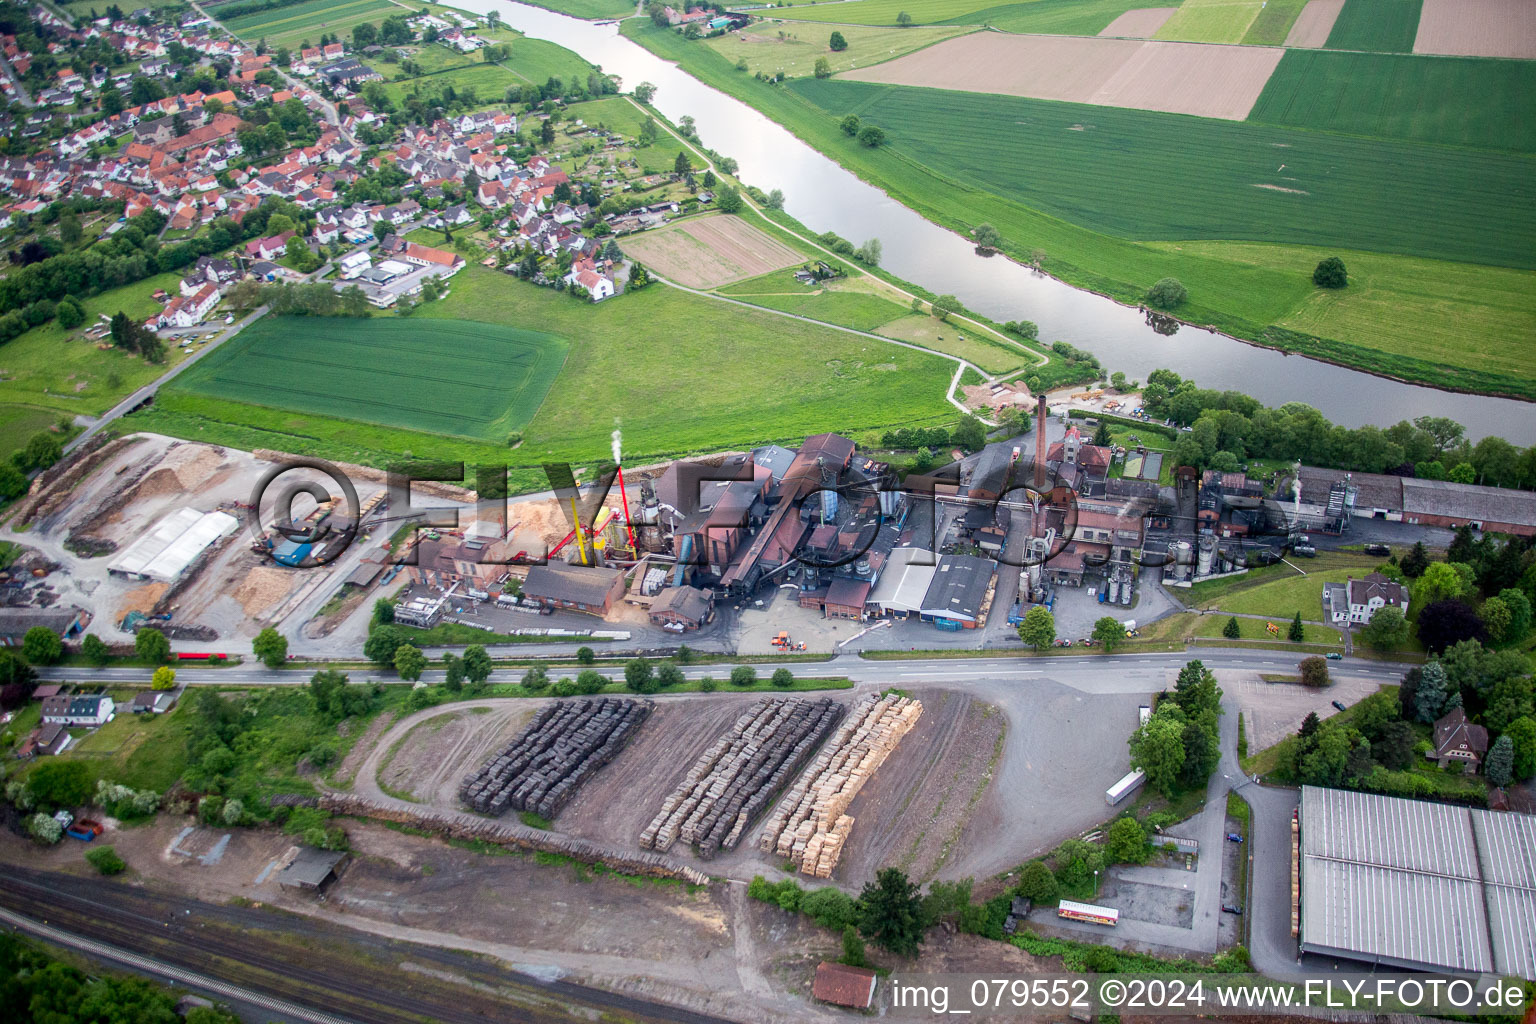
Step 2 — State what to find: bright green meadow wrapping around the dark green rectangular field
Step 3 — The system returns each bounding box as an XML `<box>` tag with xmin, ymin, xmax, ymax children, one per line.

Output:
<box><xmin>141</xmin><ymin>266</ymin><xmax>955</xmax><ymax>490</ymax></box>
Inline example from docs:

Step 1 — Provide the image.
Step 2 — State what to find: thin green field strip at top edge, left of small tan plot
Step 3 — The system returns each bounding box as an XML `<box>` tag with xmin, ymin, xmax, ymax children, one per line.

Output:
<box><xmin>773</xmin><ymin>0</ymin><xmax>1148</xmax><ymax>35</ymax></box>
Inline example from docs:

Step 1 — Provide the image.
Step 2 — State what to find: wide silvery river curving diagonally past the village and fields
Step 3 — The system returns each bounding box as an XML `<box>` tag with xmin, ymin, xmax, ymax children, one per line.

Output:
<box><xmin>452</xmin><ymin>0</ymin><xmax>1517</xmax><ymax>445</ymax></box>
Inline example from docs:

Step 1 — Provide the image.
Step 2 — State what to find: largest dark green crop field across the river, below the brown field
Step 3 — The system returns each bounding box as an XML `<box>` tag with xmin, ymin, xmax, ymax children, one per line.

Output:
<box><xmin>790</xmin><ymin>78</ymin><xmax>1536</xmax><ymax>267</ymax></box>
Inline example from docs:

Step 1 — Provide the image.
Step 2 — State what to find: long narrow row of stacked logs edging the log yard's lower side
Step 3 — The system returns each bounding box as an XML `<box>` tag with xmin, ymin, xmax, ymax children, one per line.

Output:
<box><xmin>319</xmin><ymin>794</ymin><xmax>710</xmax><ymax>886</ymax></box>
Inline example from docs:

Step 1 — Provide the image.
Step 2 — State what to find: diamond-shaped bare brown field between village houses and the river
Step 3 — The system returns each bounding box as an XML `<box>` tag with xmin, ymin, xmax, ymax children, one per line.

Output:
<box><xmin>622</xmin><ymin>216</ymin><xmax>805</xmax><ymax>289</ymax></box>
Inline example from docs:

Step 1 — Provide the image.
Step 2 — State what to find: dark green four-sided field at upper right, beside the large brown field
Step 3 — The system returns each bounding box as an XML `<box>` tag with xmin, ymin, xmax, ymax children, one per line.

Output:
<box><xmin>1249</xmin><ymin>49</ymin><xmax>1536</xmax><ymax>154</ymax></box>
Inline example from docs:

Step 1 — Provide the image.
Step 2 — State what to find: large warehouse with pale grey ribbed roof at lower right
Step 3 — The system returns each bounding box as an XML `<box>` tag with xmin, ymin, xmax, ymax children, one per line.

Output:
<box><xmin>1299</xmin><ymin>786</ymin><xmax>1536</xmax><ymax>981</ymax></box>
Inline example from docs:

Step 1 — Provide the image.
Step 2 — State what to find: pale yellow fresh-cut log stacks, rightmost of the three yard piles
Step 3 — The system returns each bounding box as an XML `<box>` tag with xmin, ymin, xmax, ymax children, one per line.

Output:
<box><xmin>757</xmin><ymin>694</ymin><xmax>923</xmax><ymax>878</ymax></box>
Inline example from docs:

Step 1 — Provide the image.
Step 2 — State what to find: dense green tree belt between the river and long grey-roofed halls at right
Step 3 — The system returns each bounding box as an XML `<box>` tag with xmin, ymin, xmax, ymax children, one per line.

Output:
<box><xmin>1141</xmin><ymin>370</ymin><xmax>1536</xmax><ymax>490</ymax></box>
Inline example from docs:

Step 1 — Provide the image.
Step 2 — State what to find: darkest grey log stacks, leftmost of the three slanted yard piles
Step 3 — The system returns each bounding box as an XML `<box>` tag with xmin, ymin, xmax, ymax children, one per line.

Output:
<box><xmin>459</xmin><ymin>697</ymin><xmax>654</xmax><ymax>818</ymax></box>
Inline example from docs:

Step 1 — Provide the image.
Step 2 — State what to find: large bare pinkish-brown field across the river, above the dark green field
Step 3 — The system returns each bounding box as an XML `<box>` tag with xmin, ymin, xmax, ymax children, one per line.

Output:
<box><xmin>840</xmin><ymin>32</ymin><xmax>1284</xmax><ymax>124</ymax></box>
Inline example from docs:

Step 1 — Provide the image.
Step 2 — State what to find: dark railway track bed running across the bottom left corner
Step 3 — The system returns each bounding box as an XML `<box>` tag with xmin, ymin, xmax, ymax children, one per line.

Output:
<box><xmin>0</xmin><ymin>867</ymin><xmax>725</xmax><ymax>1024</ymax></box>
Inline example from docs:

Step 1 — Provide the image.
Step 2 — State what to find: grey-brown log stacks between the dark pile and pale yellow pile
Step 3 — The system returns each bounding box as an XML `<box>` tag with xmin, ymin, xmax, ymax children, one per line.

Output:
<box><xmin>641</xmin><ymin>697</ymin><xmax>843</xmax><ymax>857</ymax></box>
